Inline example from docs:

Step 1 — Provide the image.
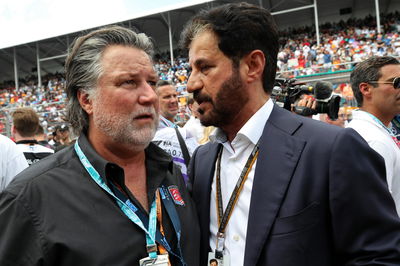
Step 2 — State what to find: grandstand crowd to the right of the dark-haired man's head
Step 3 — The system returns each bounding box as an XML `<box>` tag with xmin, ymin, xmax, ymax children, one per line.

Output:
<box><xmin>278</xmin><ymin>11</ymin><xmax>400</xmax><ymax>76</ymax></box>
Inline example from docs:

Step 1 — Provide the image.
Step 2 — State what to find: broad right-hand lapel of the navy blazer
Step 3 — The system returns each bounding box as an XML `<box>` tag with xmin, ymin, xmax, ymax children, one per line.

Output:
<box><xmin>244</xmin><ymin>106</ymin><xmax>305</xmax><ymax>266</ymax></box>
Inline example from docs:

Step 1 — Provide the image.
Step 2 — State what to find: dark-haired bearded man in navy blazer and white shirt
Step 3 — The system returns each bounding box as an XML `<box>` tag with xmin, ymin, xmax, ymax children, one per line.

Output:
<box><xmin>181</xmin><ymin>3</ymin><xmax>400</xmax><ymax>266</ymax></box>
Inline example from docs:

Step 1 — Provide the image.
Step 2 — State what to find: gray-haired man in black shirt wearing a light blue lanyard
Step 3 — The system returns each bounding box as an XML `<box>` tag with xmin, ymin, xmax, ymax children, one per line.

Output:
<box><xmin>0</xmin><ymin>26</ymin><xmax>199</xmax><ymax>266</ymax></box>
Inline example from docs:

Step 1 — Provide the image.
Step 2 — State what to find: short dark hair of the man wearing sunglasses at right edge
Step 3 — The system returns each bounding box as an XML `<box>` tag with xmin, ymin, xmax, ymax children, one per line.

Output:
<box><xmin>350</xmin><ymin>56</ymin><xmax>400</xmax><ymax>107</ymax></box>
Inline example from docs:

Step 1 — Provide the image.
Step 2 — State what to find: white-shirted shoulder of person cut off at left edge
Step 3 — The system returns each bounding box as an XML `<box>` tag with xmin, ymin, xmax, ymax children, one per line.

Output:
<box><xmin>0</xmin><ymin>134</ymin><xmax>28</xmax><ymax>192</ymax></box>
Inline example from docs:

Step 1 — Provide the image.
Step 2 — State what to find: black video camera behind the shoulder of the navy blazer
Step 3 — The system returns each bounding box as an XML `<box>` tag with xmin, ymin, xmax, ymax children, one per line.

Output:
<box><xmin>271</xmin><ymin>78</ymin><xmax>341</xmax><ymax>120</ymax></box>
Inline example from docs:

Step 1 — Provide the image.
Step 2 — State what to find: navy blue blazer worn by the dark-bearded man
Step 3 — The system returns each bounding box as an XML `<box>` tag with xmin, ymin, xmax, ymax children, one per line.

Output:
<box><xmin>189</xmin><ymin>106</ymin><xmax>400</xmax><ymax>266</ymax></box>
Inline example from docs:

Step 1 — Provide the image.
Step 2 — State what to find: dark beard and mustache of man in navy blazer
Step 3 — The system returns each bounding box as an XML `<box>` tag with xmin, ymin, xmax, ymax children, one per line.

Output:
<box><xmin>193</xmin><ymin>67</ymin><xmax>249</xmax><ymax>128</ymax></box>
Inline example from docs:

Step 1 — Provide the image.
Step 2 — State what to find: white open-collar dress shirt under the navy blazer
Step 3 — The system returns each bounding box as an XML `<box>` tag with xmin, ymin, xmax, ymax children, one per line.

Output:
<box><xmin>210</xmin><ymin>99</ymin><xmax>274</xmax><ymax>265</ymax></box>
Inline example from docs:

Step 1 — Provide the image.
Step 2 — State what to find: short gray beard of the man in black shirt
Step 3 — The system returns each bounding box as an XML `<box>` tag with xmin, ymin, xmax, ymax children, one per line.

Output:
<box><xmin>93</xmin><ymin>96</ymin><xmax>158</xmax><ymax>149</ymax></box>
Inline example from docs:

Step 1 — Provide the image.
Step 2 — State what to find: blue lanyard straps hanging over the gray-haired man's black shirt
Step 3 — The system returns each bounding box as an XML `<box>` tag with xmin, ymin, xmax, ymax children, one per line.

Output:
<box><xmin>74</xmin><ymin>140</ymin><xmax>186</xmax><ymax>265</ymax></box>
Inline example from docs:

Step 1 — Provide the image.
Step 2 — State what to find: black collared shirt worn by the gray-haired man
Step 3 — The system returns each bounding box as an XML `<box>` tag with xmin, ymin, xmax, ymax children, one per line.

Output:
<box><xmin>0</xmin><ymin>134</ymin><xmax>199</xmax><ymax>266</ymax></box>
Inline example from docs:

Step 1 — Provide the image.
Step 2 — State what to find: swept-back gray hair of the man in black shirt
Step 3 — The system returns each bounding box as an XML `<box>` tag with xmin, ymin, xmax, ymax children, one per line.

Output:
<box><xmin>65</xmin><ymin>26</ymin><xmax>154</xmax><ymax>135</ymax></box>
